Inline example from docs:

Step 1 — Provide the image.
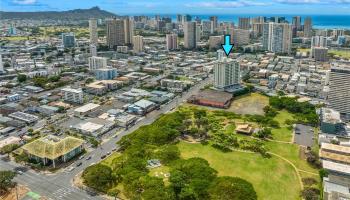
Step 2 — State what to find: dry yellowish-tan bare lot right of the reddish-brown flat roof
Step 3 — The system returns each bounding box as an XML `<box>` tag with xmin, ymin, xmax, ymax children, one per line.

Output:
<box><xmin>228</xmin><ymin>93</ymin><xmax>269</xmax><ymax>115</ymax></box>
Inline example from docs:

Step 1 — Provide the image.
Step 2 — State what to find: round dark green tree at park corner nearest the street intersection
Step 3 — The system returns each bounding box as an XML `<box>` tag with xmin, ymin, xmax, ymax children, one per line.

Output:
<box><xmin>82</xmin><ymin>164</ymin><xmax>115</xmax><ymax>192</ymax></box>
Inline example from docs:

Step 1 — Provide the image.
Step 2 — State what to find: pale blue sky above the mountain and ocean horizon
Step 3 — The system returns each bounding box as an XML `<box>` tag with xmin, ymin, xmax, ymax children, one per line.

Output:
<box><xmin>0</xmin><ymin>0</ymin><xmax>350</xmax><ymax>15</ymax></box>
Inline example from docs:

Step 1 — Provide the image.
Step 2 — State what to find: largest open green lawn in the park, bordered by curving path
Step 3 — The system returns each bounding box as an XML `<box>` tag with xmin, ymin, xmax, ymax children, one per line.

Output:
<box><xmin>178</xmin><ymin>142</ymin><xmax>300</xmax><ymax>200</ymax></box>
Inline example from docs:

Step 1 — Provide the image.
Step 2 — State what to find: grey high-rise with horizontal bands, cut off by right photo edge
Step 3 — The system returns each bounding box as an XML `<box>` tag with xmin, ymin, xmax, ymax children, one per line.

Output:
<box><xmin>328</xmin><ymin>67</ymin><xmax>350</xmax><ymax>119</ymax></box>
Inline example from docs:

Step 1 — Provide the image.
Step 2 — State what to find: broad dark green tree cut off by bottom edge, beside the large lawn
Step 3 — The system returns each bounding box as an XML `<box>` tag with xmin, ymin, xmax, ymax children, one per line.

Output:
<box><xmin>209</xmin><ymin>176</ymin><xmax>258</xmax><ymax>200</ymax></box>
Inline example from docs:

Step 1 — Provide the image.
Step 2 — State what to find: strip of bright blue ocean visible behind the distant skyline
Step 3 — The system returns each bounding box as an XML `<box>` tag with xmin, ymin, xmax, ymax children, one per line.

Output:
<box><xmin>133</xmin><ymin>14</ymin><xmax>350</xmax><ymax>29</ymax></box>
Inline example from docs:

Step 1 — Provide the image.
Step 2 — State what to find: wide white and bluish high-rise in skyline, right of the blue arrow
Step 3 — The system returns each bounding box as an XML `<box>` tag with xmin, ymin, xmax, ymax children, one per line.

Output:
<box><xmin>263</xmin><ymin>22</ymin><xmax>292</xmax><ymax>53</ymax></box>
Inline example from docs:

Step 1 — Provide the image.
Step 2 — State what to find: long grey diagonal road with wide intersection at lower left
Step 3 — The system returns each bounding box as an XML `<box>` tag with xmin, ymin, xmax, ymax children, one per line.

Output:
<box><xmin>0</xmin><ymin>78</ymin><xmax>211</xmax><ymax>200</ymax></box>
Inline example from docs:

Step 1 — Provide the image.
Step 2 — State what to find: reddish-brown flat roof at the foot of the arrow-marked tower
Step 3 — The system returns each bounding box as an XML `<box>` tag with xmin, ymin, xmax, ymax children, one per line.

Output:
<box><xmin>194</xmin><ymin>90</ymin><xmax>233</xmax><ymax>103</ymax></box>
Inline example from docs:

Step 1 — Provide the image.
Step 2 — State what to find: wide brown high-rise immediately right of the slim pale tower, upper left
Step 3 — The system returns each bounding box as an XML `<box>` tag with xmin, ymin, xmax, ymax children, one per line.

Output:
<box><xmin>106</xmin><ymin>18</ymin><xmax>125</xmax><ymax>48</ymax></box>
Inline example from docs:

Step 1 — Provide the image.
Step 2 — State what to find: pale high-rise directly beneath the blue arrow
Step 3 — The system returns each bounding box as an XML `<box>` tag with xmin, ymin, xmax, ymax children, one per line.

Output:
<box><xmin>214</xmin><ymin>57</ymin><xmax>240</xmax><ymax>89</ymax></box>
